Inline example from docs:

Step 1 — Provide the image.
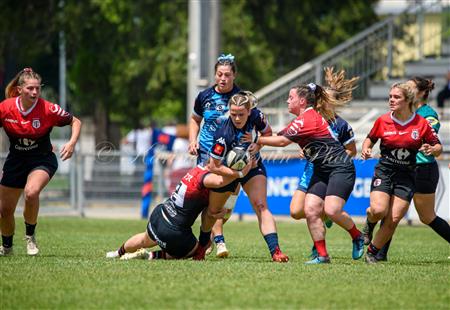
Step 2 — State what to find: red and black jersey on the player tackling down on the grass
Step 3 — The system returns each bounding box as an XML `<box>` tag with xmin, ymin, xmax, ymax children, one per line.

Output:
<box><xmin>163</xmin><ymin>166</ymin><xmax>209</xmax><ymax>228</ymax></box>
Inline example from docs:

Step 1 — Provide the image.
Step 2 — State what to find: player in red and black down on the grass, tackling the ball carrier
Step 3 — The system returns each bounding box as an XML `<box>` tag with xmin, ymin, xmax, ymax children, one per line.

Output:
<box><xmin>106</xmin><ymin>161</ymin><xmax>253</xmax><ymax>260</ymax></box>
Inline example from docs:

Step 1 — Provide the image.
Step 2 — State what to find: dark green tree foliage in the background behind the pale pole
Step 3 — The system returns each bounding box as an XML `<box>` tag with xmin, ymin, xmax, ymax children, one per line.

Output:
<box><xmin>0</xmin><ymin>0</ymin><xmax>376</xmax><ymax>144</ymax></box>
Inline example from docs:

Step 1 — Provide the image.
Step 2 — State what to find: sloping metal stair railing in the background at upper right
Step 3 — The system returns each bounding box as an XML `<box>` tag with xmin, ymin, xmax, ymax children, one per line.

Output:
<box><xmin>255</xmin><ymin>0</ymin><xmax>450</xmax><ymax>108</ymax></box>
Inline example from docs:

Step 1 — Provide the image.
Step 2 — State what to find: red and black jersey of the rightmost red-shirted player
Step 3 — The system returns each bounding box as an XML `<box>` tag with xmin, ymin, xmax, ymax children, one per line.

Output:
<box><xmin>367</xmin><ymin>112</ymin><xmax>441</xmax><ymax>170</ymax></box>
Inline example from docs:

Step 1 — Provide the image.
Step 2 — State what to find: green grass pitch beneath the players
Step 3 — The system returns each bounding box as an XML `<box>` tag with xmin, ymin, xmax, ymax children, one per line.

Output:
<box><xmin>0</xmin><ymin>218</ymin><xmax>450</xmax><ymax>309</ymax></box>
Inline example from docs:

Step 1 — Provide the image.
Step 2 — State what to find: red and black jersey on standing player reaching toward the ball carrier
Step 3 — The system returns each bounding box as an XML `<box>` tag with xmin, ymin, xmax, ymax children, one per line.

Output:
<box><xmin>278</xmin><ymin>108</ymin><xmax>352</xmax><ymax>171</ymax></box>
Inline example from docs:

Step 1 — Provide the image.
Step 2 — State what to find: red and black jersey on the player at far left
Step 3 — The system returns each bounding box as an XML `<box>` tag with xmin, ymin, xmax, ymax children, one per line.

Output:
<box><xmin>0</xmin><ymin>97</ymin><xmax>73</xmax><ymax>155</ymax></box>
